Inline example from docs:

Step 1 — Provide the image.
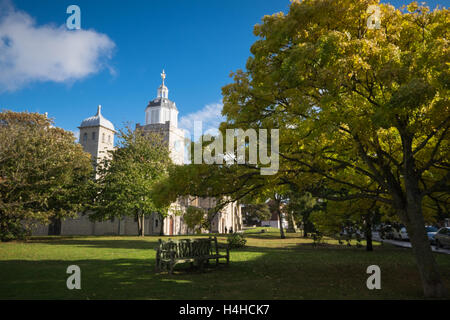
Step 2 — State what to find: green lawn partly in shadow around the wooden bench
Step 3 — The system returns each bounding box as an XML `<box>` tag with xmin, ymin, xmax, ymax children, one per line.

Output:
<box><xmin>0</xmin><ymin>228</ymin><xmax>450</xmax><ymax>299</ymax></box>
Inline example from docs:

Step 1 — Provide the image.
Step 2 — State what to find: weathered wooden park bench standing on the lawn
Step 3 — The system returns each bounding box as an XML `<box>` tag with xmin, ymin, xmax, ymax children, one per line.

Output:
<box><xmin>156</xmin><ymin>237</ymin><xmax>230</xmax><ymax>274</ymax></box>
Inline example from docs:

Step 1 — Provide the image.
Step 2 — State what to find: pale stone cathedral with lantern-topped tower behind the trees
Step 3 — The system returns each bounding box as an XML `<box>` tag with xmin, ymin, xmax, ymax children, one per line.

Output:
<box><xmin>33</xmin><ymin>70</ymin><xmax>242</xmax><ymax>236</ymax></box>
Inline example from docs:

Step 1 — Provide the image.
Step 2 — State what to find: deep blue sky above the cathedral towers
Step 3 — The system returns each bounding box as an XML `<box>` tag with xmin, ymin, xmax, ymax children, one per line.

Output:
<box><xmin>0</xmin><ymin>0</ymin><xmax>446</xmax><ymax>138</ymax></box>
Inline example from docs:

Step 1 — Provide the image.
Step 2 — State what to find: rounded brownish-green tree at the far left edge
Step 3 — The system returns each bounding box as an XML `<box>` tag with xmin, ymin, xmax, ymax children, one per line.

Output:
<box><xmin>0</xmin><ymin>111</ymin><xmax>93</xmax><ymax>241</ymax></box>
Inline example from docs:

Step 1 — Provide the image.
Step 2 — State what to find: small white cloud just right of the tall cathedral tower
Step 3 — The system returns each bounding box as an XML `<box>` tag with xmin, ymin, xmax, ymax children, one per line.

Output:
<box><xmin>178</xmin><ymin>103</ymin><xmax>225</xmax><ymax>136</ymax></box>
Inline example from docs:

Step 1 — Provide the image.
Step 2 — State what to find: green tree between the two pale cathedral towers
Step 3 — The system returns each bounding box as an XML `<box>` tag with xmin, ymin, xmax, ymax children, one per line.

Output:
<box><xmin>90</xmin><ymin>128</ymin><xmax>171</xmax><ymax>236</ymax></box>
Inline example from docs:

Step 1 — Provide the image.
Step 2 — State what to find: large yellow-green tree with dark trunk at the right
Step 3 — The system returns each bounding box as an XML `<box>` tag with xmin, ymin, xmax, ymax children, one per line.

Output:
<box><xmin>222</xmin><ymin>0</ymin><xmax>450</xmax><ymax>297</ymax></box>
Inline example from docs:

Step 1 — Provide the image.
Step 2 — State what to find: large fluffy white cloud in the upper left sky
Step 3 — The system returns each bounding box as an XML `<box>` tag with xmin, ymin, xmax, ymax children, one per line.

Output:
<box><xmin>0</xmin><ymin>0</ymin><xmax>115</xmax><ymax>92</ymax></box>
